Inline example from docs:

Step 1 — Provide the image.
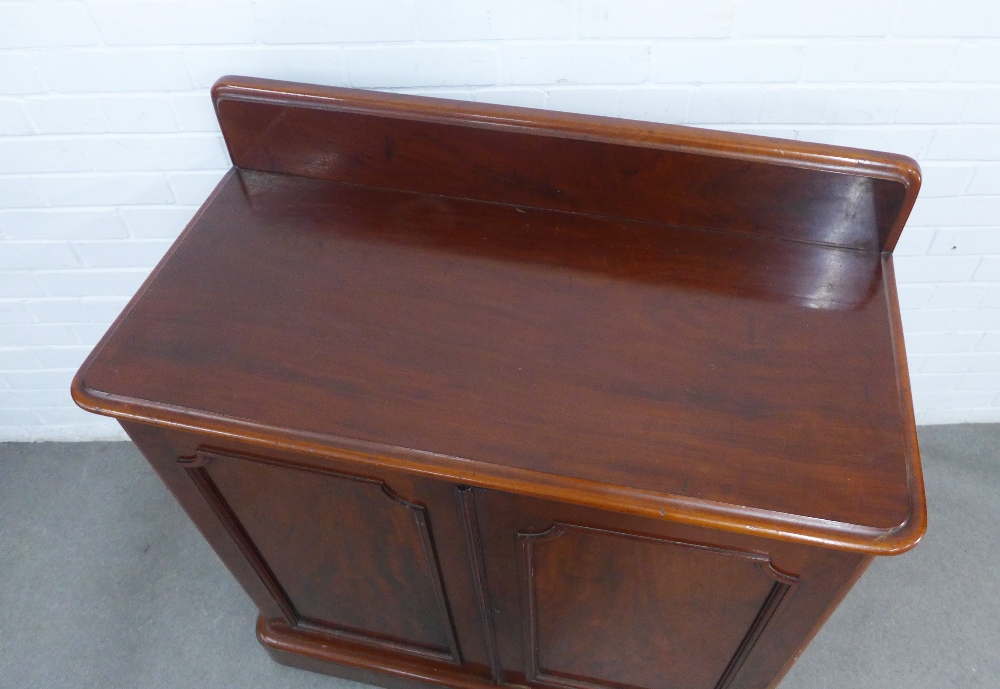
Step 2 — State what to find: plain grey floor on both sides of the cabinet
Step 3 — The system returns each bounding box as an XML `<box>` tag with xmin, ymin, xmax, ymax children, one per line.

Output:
<box><xmin>0</xmin><ymin>425</ymin><xmax>1000</xmax><ymax>689</ymax></box>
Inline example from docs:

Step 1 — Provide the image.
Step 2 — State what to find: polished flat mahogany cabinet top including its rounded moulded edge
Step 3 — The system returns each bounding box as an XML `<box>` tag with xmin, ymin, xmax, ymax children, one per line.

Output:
<box><xmin>73</xmin><ymin>78</ymin><xmax>925</xmax><ymax>552</ymax></box>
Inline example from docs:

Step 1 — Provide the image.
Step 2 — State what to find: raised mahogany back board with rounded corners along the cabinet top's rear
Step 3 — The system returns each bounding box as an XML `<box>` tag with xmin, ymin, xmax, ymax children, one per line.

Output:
<box><xmin>212</xmin><ymin>76</ymin><xmax>920</xmax><ymax>251</ymax></box>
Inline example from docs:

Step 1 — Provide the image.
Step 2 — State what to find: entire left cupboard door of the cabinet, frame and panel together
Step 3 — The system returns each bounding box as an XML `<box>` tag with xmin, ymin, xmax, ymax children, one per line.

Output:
<box><xmin>123</xmin><ymin>422</ymin><xmax>489</xmax><ymax>674</ymax></box>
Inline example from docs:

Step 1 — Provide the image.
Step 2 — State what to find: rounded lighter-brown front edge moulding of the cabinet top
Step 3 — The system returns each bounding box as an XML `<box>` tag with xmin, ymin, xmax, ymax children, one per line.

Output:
<box><xmin>72</xmin><ymin>384</ymin><xmax>926</xmax><ymax>555</ymax></box>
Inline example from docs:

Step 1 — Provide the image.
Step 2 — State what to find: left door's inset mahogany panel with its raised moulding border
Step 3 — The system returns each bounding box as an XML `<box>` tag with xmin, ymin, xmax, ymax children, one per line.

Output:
<box><xmin>186</xmin><ymin>452</ymin><xmax>462</xmax><ymax>665</ymax></box>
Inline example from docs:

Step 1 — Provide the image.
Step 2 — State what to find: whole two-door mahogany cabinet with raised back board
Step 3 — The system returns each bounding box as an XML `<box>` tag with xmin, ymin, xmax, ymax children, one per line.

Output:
<box><xmin>73</xmin><ymin>77</ymin><xmax>926</xmax><ymax>689</ymax></box>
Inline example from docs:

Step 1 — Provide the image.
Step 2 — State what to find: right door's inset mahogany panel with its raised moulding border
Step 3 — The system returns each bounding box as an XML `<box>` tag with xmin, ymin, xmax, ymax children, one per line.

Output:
<box><xmin>518</xmin><ymin>523</ymin><xmax>795</xmax><ymax>689</ymax></box>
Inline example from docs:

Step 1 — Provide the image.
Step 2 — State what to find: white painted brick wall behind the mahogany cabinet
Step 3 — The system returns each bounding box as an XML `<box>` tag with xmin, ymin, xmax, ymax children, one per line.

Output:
<box><xmin>0</xmin><ymin>0</ymin><xmax>1000</xmax><ymax>440</ymax></box>
